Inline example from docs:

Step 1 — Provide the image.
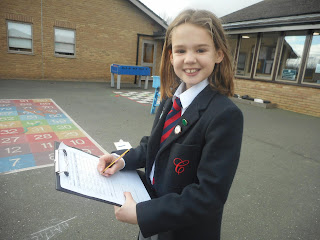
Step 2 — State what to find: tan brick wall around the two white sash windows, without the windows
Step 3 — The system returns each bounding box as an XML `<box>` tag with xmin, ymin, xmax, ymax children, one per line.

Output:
<box><xmin>0</xmin><ymin>0</ymin><xmax>162</xmax><ymax>82</ymax></box>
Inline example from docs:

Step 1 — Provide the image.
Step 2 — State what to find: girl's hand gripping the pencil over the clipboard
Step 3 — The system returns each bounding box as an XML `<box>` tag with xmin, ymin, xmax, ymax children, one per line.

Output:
<box><xmin>97</xmin><ymin>154</ymin><xmax>124</xmax><ymax>177</ymax></box>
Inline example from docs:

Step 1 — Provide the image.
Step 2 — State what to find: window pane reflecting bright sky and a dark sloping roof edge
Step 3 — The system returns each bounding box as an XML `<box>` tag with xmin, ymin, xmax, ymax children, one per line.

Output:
<box><xmin>277</xmin><ymin>32</ymin><xmax>306</xmax><ymax>81</ymax></box>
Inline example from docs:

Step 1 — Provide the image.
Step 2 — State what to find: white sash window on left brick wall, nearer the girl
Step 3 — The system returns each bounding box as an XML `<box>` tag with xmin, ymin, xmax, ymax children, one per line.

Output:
<box><xmin>54</xmin><ymin>28</ymin><xmax>75</xmax><ymax>56</ymax></box>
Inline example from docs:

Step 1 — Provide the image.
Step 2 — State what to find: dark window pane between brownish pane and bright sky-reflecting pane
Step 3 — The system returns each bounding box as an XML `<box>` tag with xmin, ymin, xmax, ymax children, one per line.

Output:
<box><xmin>255</xmin><ymin>33</ymin><xmax>279</xmax><ymax>79</ymax></box>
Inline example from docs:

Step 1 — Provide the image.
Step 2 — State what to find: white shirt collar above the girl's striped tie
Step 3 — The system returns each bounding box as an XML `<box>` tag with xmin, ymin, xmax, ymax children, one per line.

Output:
<box><xmin>172</xmin><ymin>79</ymin><xmax>209</xmax><ymax>115</ymax></box>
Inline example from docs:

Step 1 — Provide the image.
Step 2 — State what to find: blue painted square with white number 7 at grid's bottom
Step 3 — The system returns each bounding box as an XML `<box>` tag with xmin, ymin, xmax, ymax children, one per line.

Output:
<box><xmin>0</xmin><ymin>153</ymin><xmax>36</xmax><ymax>172</ymax></box>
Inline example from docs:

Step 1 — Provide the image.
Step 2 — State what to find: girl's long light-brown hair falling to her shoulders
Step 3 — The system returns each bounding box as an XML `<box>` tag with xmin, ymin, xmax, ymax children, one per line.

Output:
<box><xmin>160</xmin><ymin>9</ymin><xmax>234</xmax><ymax>99</ymax></box>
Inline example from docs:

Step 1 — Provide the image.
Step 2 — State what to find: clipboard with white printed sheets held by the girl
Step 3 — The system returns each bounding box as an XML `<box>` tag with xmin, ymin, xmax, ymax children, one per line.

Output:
<box><xmin>54</xmin><ymin>142</ymin><xmax>154</xmax><ymax>206</ymax></box>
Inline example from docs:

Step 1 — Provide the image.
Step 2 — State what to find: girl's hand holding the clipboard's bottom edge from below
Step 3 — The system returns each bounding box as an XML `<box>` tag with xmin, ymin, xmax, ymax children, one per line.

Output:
<box><xmin>114</xmin><ymin>192</ymin><xmax>138</xmax><ymax>224</ymax></box>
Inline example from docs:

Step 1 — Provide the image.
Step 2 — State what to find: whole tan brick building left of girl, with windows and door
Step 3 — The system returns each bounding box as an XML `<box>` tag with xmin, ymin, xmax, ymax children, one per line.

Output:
<box><xmin>0</xmin><ymin>0</ymin><xmax>167</xmax><ymax>82</ymax></box>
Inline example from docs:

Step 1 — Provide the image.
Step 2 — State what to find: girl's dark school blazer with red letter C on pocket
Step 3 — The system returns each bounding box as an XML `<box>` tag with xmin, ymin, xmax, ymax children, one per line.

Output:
<box><xmin>118</xmin><ymin>85</ymin><xmax>243</xmax><ymax>240</ymax></box>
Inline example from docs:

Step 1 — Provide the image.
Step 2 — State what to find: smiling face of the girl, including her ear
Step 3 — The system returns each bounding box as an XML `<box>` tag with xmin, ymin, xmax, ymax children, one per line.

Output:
<box><xmin>170</xmin><ymin>23</ymin><xmax>224</xmax><ymax>89</ymax></box>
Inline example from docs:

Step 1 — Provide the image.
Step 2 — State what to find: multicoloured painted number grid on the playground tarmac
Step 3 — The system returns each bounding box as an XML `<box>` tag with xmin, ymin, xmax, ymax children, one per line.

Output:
<box><xmin>0</xmin><ymin>99</ymin><xmax>106</xmax><ymax>173</ymax></box>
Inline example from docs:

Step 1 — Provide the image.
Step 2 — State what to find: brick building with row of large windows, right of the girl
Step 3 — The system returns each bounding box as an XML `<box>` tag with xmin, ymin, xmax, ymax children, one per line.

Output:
<box><xmin>222</xmin><ymin>0</ymin><xmax>320</xmax><ymax>117</ymax></box>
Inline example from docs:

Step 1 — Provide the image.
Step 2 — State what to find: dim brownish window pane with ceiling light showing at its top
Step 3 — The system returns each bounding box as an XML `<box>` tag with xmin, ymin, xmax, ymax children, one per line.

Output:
<box><xmin>236</xmin><ymin>34</ymin><xmax>257</xmax><ymax>77</ymax></box>
